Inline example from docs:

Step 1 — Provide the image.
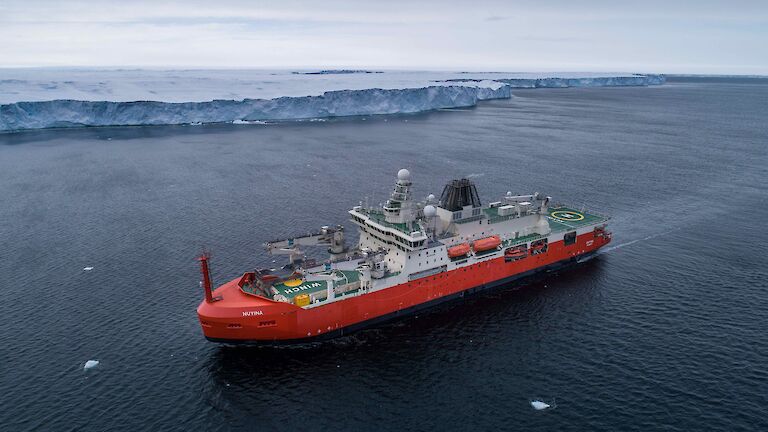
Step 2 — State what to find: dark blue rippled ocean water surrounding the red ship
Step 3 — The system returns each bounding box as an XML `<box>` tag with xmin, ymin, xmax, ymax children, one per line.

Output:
<box><xmin>0</xmin><ymin>79</ymin><xmax>768</xmax><ymax>431</ymax></box>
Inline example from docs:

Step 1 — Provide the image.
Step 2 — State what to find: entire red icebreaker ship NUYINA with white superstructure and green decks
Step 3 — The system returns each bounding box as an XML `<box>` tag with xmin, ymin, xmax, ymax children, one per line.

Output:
<box><xmin>197</xmin><ymin>169</ymin><xmax>611</xmax><ymax>345</ymax></box>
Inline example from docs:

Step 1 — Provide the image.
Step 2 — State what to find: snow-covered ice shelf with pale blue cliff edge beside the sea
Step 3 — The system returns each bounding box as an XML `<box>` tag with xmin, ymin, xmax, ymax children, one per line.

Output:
<box><xmin>0</xmin><ymin>69</ymin><xmax>664</xmax><ymax>131</ymax></box>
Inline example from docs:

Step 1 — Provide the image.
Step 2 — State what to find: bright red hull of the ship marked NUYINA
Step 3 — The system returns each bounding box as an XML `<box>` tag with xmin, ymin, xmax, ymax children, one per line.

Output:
<box><xmin>197</xmin><ymin>232</ymin><xmax>610</xmax><ymax>344</ymax></box>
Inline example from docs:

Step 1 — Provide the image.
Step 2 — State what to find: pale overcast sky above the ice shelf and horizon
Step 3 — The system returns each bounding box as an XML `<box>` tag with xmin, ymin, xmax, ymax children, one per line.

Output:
<box><xmin>0</xmin><ymin>0</ymin><xmax>768</xmax><ymax>75</ymax></box>
